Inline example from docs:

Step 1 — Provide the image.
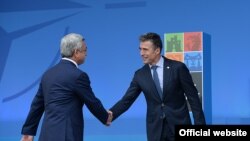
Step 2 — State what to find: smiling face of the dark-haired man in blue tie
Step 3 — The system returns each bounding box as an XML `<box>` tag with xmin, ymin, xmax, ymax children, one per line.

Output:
<box><xmin>140</xmin><ymin>41</ymin><xmax>160</xmax><ymax>65</ymax></box>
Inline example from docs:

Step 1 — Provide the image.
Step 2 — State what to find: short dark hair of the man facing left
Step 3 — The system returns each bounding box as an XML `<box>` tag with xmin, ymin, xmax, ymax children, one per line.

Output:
<box><xmin>139</xmin><ymin>32</ymin><xmax>162</xmax><ymax>51</ymax></box>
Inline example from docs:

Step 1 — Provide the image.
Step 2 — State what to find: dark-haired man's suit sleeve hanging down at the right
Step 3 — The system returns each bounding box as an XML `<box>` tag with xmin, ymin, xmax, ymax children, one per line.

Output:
<box><xmin>179</xmin><ymin>64</ymin><xmax>206</xmax><ymax>124</ymax></box>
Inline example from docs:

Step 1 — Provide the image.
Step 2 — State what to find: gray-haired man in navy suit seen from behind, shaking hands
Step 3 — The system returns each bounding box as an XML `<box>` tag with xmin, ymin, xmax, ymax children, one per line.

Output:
<box><xmin>21</xmin><ymin>33</ymin><xmax>112</xmax><ymax>141</ymax></box>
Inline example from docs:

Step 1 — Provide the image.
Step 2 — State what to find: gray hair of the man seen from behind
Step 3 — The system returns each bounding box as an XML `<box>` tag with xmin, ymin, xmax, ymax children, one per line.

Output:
<box><xmin>61</xmin><ymin>33</ymin><xmax>85</xmax><ymax>58</ymax></box>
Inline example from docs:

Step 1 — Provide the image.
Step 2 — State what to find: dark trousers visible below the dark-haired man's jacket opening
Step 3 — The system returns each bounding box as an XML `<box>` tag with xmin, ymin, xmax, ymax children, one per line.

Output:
<box><xmin>161</xmin><ymin>118</ymin><xmax>174</xmax><ymax>141</ymax></box>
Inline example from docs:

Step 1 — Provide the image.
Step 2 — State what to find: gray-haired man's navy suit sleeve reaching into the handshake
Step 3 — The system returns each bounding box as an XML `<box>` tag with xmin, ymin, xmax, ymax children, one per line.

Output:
<box><xmin>76</xmin><ymin>73</ymin><xmax>108</xmax><ymax>124</ymax></box>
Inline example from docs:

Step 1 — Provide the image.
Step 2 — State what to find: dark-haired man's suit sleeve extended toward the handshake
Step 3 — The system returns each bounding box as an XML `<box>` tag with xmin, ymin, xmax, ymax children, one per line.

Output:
<box><xmin>110</xmin><ymin>74</ymin><xmax>141</xmax><ymax>120</ymax></box>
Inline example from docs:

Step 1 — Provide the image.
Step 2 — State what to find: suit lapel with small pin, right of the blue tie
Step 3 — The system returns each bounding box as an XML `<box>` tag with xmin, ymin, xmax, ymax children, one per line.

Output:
<box><xmin>163</xmin><ymin>57</ymin><xmax>172</xmax><ymax>99</ymax></box>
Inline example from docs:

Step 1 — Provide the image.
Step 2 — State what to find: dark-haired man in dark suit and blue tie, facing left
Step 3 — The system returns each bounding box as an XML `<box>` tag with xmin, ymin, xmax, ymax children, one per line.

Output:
<box><xmin>110</xmin><ymin>33</ymin><xmax>205</xmax><ymax>141</ymax></box>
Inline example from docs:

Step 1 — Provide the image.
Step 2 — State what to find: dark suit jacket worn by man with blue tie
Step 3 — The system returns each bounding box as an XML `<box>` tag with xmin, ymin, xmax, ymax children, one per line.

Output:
<box><xmin>110</xmin><ymin>57</ymin><xmax>205</xmax><ymax>141</ymax></box>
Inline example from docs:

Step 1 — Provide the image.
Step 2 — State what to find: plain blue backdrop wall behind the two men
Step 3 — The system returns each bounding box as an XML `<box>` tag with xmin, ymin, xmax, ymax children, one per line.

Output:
<box><xmin>0</xmin><ymin>0</ymin><xmax>250</xmax><ymax>141</ymax></box>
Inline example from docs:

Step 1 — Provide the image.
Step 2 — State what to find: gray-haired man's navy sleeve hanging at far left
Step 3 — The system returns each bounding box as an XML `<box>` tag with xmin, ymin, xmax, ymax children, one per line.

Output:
<box><xmin>21</xmin><ymin>83</ymin><xmax>44</xmax><ymax>136</ymax></box>
